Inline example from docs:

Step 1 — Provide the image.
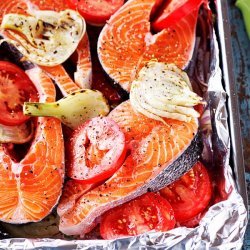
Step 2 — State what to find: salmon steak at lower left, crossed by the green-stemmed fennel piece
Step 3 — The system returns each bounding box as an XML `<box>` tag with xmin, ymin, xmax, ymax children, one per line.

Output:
<box><xmin>0</xmin><ymin>68</ymin><xmax>65</xmax><ymax>224</ymax></box>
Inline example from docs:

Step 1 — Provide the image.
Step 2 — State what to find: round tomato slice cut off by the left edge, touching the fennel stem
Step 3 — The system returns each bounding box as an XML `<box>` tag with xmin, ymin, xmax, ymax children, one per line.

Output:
<box><xmin>0</xmin><ymin>61</ymin><xmax>38</xmax><ymax>126</ymax></box>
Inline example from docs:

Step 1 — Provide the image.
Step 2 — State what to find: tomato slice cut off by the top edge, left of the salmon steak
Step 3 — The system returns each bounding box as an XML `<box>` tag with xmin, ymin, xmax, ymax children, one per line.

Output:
<box><xmin>66</xmin><ymin>0</ymin><xmax>124</xmax><ymax>26</ymax></box>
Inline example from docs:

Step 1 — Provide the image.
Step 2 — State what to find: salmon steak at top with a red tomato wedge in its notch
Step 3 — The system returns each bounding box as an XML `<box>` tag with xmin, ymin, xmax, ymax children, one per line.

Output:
<box><xmin>98</xmin><ymin>0</ymin><xmax>201</xmax><ymax>92</ymax></box>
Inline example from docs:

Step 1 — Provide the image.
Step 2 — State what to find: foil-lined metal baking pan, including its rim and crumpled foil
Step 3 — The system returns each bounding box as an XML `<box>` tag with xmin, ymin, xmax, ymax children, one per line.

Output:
<box><xmin>0</xmin><ymin>0</ymin><xmax>247</xmax><ymax>250</ymax></box>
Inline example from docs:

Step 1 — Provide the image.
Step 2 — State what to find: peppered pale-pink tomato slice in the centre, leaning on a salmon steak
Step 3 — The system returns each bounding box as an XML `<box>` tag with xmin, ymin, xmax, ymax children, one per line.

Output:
<box><xmin>68</xmin><ymin>117</ymin><xmax>126</xmax><ymax>183</ymax></box>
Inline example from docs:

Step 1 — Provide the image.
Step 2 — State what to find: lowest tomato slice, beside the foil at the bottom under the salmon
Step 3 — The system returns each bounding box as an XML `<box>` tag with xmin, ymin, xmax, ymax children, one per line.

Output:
<box><xmin>100</xmin><ymin>193</ymin><xmax>175</xmax><ymax>240</ymax></box>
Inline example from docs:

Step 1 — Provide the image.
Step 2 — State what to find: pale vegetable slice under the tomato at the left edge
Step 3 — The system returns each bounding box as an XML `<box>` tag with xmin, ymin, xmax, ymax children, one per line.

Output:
<box><xmin>0</xmin><ymin>122</ymin><xmax>34</xmax><ymax>144</ymax></box>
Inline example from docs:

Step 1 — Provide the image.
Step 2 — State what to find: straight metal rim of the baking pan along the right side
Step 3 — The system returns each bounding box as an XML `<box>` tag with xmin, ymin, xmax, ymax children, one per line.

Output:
<box><xmin>217</xmin><ymin>0</ymin><xmax>248</xmax><ymax>207</ymax></box>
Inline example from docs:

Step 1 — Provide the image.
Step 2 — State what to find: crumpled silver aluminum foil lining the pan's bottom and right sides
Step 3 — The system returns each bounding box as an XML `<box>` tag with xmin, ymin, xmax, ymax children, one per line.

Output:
<box><xmin>0</xmin><ymin>5</ymin><xmax>247</xmax><ymax>250</ymax></box>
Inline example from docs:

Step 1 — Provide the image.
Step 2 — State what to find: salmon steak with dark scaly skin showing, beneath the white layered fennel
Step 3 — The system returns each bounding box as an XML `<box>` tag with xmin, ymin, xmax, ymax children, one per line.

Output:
<box><xmin>59</xmin><ymin>101</ymin><xmax>200</xmax><ymax>235</ymax></box>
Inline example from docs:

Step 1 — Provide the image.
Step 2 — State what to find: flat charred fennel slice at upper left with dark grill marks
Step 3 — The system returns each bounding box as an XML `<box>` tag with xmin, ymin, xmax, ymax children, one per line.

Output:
<box><xmin>1</xmin><ymin>10</ymin><xmax>86</xmax><ymax>66</ymax></box>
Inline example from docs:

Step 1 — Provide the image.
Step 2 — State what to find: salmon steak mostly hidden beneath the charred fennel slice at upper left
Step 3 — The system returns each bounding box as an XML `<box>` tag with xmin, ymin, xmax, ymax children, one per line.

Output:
<box><xmin>0</xmin><ymin>0</ymin><xmax>92</xmax><ymax>96</ymax></box>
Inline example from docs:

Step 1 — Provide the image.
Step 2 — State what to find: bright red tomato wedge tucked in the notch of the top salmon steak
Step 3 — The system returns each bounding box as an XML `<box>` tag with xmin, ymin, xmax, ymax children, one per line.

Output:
<box><xmin>152</xmin><ymin>0</ymin><xmax>207</xmax><ymax>32</ymax></box>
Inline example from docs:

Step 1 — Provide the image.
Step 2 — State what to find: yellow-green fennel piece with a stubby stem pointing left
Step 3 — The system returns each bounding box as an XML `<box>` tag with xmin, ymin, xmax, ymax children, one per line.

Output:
<box><xmin>23</xmin><ymin>89</ymin><xmax>109</xmax><ymax>129</ymax></box>
